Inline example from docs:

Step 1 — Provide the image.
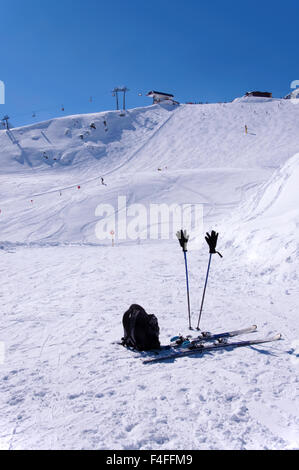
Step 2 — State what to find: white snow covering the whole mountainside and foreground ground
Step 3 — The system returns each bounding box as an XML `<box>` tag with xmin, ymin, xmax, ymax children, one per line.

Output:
<box><xmin>0</xmin><ymin>99</ymin><xmax>299</xmax><ymax>450</ymax></box>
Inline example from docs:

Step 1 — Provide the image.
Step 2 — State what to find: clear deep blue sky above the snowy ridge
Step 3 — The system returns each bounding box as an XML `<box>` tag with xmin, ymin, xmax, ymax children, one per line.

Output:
<box><xmin>0</xmin><ymin>0</ymin><xmax>299</xmax><ymax>125</ymax></box>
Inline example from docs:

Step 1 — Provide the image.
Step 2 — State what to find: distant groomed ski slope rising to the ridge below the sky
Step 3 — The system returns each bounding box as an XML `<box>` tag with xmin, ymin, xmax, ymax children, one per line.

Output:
<box><xmin>0</xmin><ymin>100</ymin><xmax>299</xmax><ymax>248</ymax></box>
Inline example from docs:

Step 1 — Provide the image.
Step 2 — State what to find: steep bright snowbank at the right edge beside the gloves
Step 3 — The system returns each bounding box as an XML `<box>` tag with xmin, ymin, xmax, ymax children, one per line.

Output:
<box><xmin>224</xmin><ymin>153</ymin><xmax>299</xmax><ymax>279</ymax></box>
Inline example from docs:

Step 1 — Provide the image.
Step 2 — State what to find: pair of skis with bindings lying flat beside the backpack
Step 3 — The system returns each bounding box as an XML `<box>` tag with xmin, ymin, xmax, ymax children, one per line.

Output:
<box><xmin>143</xmin><ymin>325</ymin><xmax>281</xmax><ymax>364</ymax></box>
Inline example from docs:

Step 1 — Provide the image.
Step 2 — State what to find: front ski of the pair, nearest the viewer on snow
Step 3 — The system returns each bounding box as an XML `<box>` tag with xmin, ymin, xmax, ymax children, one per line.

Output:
<box><xmin>143</xmin><ymin>334</ymin><xmax>282</xmax><ymax>364</ymax></box>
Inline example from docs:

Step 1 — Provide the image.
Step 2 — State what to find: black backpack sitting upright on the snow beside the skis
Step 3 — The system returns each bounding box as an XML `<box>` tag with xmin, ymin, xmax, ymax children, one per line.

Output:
<box><xmin>122</xmin><ymin>305</ymin><xmax>160</xmax><ymax>351</ymax></box>
